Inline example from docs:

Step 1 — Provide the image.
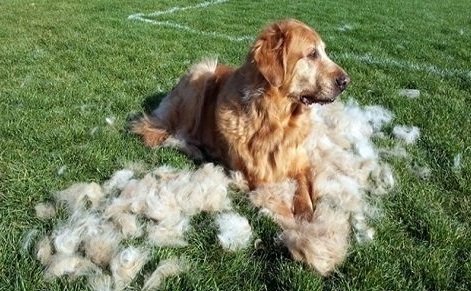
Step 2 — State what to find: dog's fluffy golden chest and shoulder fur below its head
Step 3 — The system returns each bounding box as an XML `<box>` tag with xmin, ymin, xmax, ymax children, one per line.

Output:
<box><xmin>216</xmin><ymin>86</ymin><xmax>311</xmax><ymax>185</ymax></box>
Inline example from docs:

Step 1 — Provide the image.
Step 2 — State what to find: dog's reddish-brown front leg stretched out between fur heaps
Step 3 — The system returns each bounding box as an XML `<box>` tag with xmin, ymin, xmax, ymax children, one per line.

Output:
<box><xmin>293</xmin><ymin>167</ymin><xmax>316</xmax><ymax>221</ymax></box>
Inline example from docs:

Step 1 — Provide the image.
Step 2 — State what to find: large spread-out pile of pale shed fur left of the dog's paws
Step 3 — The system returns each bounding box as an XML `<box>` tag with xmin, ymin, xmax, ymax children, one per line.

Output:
<box><xmin>33</xmin><ymin>164</ymin><xmax>238</xmax><ymax>289</ymax></box>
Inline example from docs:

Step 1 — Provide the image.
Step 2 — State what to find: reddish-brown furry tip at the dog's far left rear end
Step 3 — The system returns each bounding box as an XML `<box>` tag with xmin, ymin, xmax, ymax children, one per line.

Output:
<box><xmin>130</xmin><ymin>114</ymin><xmax>170</xmax><ymax>148</ymax></box>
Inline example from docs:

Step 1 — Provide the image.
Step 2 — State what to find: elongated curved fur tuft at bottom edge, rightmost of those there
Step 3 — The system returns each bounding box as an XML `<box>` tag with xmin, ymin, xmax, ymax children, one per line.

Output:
<box><xmin>142</xmin><ymin>258</ymin><xmax>188</xmax><ymax>291</ymax></box>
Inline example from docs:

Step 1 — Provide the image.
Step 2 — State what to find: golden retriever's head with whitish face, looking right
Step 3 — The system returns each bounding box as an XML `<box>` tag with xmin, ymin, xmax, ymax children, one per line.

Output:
<box><xmin>249</xmin><ymin>20</ymin><xmax>350</xmax><ymax>105</ymax></box>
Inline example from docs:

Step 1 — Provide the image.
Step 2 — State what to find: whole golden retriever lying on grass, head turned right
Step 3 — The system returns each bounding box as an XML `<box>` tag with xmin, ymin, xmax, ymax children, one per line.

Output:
<box><xmin>132</xmin><ymin>20</ymin><xmax>350</xmax><ymax>221</ymax></box>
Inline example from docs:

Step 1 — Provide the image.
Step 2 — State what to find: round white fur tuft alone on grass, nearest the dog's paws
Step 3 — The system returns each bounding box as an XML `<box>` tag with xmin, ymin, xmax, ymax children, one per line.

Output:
<box><xmin>216</xmin><ymin>212</ymin><xmax>252</xmax><ymax>251</ymax></box>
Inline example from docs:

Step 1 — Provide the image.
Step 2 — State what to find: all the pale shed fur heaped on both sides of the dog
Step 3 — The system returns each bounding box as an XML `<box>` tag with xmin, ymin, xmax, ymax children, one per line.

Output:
<box><xmin>30</xmin><ymin>97</ymin><xmax>418</xmax><ymax>290</ymax></box>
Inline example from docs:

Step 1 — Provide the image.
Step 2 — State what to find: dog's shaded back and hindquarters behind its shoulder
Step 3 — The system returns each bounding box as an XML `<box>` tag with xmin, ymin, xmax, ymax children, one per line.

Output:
<box><xmin>132</xmin><ymin>59</ymin><xmax>233</xmax><ymax>158</ymax></box>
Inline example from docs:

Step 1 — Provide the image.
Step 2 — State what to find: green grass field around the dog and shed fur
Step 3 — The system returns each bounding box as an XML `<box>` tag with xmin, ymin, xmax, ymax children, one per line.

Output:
<box><xmin>0</xmin><ymin>0</ymin><xmax>471</xmax><ymax>290</ymax></box>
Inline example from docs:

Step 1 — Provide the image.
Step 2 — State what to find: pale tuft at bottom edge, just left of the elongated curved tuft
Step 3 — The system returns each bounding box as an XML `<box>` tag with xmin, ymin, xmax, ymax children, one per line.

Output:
<box><xmin>110</xmin><ymin>246</ymin><xmax>148</xmax><ymax>290</ymax></box>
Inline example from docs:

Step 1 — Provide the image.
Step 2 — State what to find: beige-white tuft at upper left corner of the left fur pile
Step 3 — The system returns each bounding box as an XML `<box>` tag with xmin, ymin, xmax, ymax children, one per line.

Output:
<box><xmin>55</xmin><ymin>183</ymin><xmax>105</xmax><ymax>212</ymax></box>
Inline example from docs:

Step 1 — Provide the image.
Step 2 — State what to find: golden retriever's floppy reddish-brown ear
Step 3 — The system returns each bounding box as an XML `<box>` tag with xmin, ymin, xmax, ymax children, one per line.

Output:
<box><xmin>251</xmin><ymin>23</ymin><xmax>287</xmax><ymax>87</ymax></box>
